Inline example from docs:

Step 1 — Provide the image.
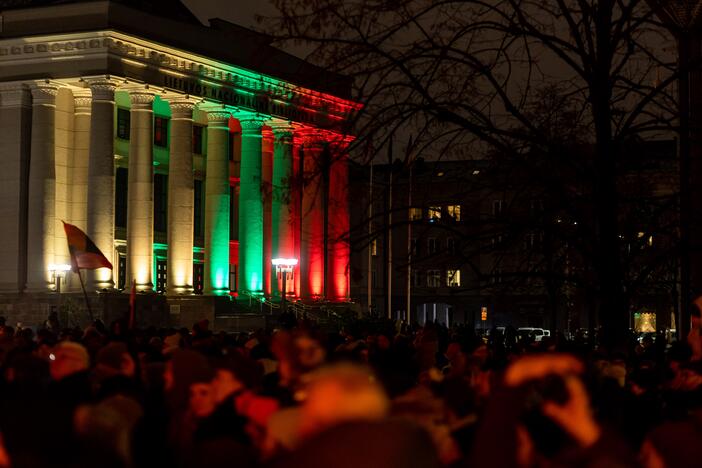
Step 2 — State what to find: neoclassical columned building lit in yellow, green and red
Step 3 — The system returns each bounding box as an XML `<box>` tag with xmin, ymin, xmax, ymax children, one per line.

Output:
<box><xmin>0</xmin><ymin>0</ymin><xmax>358</xmax><ymax>320</ymax></box>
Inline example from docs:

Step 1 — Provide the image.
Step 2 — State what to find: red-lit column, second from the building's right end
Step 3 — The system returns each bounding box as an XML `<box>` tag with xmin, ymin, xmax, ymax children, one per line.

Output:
<box><xmin>300</xmin><ymin>133</ymin><xmax>324</xmax><ymax>298</ymax></box>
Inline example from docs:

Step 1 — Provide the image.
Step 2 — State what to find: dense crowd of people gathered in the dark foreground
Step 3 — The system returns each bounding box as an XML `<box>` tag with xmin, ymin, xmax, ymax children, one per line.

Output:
<box><xmin>0</xmin><ymin>310</ymin><xmax>702</xmax><ymax>468</ymax></box>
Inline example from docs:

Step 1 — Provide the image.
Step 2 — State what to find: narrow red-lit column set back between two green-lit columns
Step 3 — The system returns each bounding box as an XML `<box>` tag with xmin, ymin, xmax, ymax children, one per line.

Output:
<box><xmin>261</xmin><ymin>127</ymin><xmax>273</xmax><ymax>296</ymax></box>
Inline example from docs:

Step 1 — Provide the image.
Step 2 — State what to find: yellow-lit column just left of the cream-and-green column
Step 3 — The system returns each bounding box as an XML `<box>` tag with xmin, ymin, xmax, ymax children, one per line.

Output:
<box><xmin>167</xmin><ymin>101</ymin><xmax>195</xmax><ymax>294</ymax></box>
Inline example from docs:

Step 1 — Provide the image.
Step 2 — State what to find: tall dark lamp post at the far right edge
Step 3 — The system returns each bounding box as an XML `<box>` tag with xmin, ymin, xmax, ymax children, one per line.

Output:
<box><xmin>648</xmin><ymin>0</ymin><xmax>702</xmax><ymax>339</ymax></box>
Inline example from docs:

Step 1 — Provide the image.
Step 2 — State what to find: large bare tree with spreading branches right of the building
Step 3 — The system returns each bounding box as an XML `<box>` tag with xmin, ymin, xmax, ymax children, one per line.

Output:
<box><xmin>263</xmin><ymin>0</ymin><xmax>676</xmax><ymax>343</ymax></box>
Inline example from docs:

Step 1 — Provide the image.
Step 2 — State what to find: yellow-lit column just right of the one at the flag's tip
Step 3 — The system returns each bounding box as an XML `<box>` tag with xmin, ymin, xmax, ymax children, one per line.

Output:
<box><xmin>125</xmin><ymin>90</ymin><xmax>154</xmax><ymax>291</ymax></box>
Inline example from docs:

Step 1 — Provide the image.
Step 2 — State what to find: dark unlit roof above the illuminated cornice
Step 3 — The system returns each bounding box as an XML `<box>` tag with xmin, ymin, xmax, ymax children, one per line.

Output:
<box><xmin>0</xmin><ymin>0</ymin><xmax>351</xmax><ymax>99</ymax></box>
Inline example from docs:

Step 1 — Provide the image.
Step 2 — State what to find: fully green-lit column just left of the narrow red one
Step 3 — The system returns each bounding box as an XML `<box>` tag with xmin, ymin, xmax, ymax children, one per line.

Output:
<box><xmin>239</xmin><ymin>119</ymin><xmax>263</xmax><ymax>293</ymax></box>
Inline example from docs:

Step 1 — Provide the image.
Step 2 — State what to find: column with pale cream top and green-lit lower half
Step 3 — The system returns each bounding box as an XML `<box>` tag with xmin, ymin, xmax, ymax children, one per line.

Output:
<box><xmin>204</xmin><ymin>110</ymin><xmax>231</xmax><ymax>294</ymax></box>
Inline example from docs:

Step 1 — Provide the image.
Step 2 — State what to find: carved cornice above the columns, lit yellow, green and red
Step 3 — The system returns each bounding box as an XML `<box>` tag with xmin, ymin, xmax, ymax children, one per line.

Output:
<box><xmin>0</xmin><ymin>30</ymin><xmax>361</xmax><ymax>134</ymax></box>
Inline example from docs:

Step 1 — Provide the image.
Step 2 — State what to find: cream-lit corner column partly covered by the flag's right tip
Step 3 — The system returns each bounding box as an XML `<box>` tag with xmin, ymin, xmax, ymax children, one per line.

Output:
<box><xmin>86</xmin><ymin>80</ymin><xmax>117</xmax><ymax>289</ymax></box>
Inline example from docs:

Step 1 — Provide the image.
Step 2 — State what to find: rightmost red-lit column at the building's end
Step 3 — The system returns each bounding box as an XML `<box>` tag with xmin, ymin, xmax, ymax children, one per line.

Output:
<box><xmin>327</xmin><ymin>142</ymin><xmax>351</xmax><ymax>301</ymax></box>
